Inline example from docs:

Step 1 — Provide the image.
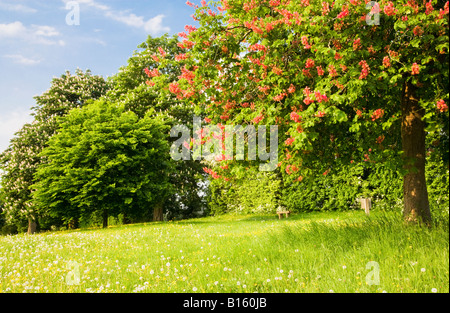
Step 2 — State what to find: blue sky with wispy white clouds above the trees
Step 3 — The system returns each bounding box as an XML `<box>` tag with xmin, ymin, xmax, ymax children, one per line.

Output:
<box><xmin>0</xmin><ymin>0</ymin><xmax>198</xmax><ymax>151</ymax></box>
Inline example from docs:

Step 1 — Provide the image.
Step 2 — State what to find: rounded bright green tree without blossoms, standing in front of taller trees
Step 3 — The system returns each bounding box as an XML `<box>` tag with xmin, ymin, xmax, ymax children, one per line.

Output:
<box><xmin>33</xmin><ymin>100</ymin><xmax>172</xmax><ymax>227</ymax></box>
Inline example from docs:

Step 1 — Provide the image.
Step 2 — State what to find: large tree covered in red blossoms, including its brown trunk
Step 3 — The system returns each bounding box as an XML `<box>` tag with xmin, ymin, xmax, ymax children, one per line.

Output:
<box><xmin>149</xmin><ymin>0</ymin><xmax>449</xmax><ymax>223</ymax></box>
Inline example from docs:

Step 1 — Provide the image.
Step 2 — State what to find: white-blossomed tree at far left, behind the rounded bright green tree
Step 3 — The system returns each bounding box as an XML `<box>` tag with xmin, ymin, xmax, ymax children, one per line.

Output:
<box><xmin>0</xmin><ymin>70</ymin><xmax>108</xmax><ymax>233</ymax></box>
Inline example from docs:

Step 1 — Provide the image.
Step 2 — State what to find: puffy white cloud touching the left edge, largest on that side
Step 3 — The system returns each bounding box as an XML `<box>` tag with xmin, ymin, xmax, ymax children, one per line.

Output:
<box><xmin>0</xmin><ymin>21</ymin><xmax>65</xmax><ymax>46</ymax></box>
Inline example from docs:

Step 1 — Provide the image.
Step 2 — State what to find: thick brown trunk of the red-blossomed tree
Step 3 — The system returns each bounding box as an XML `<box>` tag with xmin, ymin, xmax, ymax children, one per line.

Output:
<box><xmin>401</xmin><ymin>78</ymin><xmax>431</xmax><ymax>225</ymax></box>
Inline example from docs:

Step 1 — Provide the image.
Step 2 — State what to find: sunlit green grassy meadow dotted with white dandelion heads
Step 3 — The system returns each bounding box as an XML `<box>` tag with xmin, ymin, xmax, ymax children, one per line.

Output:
<box><xmin>0</xmin><ymin>211</ymin><xmax>449</xmax><ymax>293</ymax></box>
